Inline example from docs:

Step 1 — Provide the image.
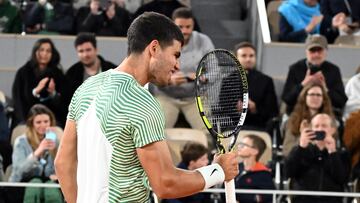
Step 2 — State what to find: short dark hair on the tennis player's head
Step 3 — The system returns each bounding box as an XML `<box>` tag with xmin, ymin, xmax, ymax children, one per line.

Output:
<box><xmin>127</xmin><ymin>12</ymin><xmax>184</xmax><ymax>56</ymax></box>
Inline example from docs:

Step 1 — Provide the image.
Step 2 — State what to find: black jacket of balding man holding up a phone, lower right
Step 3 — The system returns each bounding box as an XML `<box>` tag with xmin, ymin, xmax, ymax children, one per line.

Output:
<box><xmin>285</xmin><ymin>144</ymin><xmax>350</xmax><ymax>203</ymax></box>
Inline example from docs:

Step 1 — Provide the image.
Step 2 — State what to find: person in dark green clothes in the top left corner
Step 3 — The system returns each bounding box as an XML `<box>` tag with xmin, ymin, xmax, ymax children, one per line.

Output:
<box><xmin>0</xmin><ymin>0</ymin><xmax>21</xmax><ymax>33</ymax></box>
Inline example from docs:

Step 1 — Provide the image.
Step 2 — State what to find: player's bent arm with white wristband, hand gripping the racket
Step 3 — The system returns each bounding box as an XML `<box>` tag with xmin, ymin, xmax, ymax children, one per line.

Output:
<box><xmin>136</xmin><ymin>141</ymin><xmax>239</xmax><ymax>199</ymax></box>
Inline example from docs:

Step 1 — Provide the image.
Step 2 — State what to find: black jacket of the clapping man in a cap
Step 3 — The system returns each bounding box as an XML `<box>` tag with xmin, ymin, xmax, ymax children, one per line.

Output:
<box><xmin>282</xmin><ymin>59</ymin><xmax>347</xmax><ymax>115</ymax></box>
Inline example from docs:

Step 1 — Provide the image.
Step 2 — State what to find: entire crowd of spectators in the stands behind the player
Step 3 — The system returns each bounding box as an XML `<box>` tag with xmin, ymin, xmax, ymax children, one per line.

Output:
<box><xmin>0</xmin><ymin>0</ymin><xmax>360</xmax><ymax>203</ymax></box>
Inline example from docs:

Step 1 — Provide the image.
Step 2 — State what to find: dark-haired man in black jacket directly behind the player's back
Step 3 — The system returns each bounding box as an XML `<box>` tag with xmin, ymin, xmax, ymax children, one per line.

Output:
<box><xmin>65</xmin><ymin>33</ymin><xmax>116</xmax><ymax>106</ymax></box>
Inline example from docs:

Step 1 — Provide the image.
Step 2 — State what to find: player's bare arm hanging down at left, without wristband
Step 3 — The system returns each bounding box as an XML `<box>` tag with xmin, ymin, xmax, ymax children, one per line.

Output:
<box><xmin>55</xmin><ymin>120</ymin><xmax>77</xmax><ymax>203</ymax></box>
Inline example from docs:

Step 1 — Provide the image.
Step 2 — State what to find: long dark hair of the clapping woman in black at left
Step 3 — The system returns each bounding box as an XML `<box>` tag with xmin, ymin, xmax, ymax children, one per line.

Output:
<box><xmin>30</xmin><ymin>38</ymin><xmax>60</xmax><ymax>68</ymax></box>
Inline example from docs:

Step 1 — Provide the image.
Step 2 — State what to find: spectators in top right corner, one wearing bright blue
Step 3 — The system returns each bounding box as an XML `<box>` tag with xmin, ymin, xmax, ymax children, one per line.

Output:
<box><xmin>278</xmin><ymin>0</ymin><xmax>360</xmax><ymax>43</ymax></box>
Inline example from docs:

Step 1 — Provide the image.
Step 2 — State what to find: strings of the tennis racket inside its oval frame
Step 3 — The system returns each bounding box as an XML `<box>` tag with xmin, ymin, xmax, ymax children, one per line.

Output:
<box><xmin>198</xmin><ymin>52</ymin><xmax>243</xmax><ymax>137</ymax></box>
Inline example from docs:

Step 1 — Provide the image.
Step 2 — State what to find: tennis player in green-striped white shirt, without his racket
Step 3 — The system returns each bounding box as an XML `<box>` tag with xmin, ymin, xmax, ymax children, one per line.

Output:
<box><xmin>55</xmin><ymin>12</ymin><xmax>238</xmax><ymax>203</ymax></box>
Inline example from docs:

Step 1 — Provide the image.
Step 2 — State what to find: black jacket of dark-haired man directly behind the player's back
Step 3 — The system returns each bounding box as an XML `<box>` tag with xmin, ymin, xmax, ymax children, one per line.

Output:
<box><xmin>65</xmin><ymin>56</ymin><xmax>116</xmax><ymax>107</ymax></box>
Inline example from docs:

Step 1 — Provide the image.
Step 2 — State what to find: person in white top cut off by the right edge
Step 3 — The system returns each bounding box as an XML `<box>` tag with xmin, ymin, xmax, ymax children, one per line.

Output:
<box><xmin>344</xmin><ymin>66</ymin><xmax>360</xmax><ymax>119</ymax></box>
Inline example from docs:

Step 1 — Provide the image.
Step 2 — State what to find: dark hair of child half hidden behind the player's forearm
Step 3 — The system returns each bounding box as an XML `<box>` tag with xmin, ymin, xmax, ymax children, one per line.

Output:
<box><xmin>180</xmin><ymin>142</ymin><xmax>208</xmax><ymax>166</ymax></box>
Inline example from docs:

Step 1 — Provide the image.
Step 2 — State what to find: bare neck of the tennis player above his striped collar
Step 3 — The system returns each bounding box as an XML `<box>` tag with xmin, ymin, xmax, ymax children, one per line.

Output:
<box><xmin>115</xmin><ymin>55</ymin><xmax>149</xmax><ymax>86</ymax></box>
